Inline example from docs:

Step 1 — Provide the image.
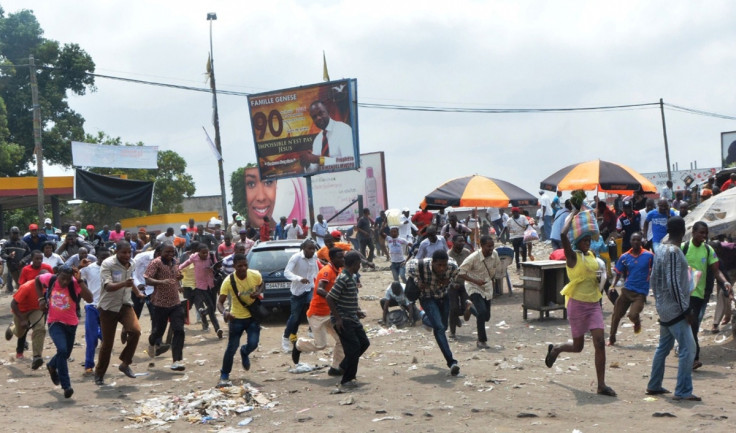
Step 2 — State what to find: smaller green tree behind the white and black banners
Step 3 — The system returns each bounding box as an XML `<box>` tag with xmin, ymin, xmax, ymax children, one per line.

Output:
<box><xmin>80</xmin><ymin>131</ymin><xmax>196</xmax><ymax>226</ymax></box>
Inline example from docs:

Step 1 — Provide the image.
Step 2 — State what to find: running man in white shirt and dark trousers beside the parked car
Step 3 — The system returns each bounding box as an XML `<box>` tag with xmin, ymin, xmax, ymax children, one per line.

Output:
<box><xmin>281</xmin><ymin>239</ymin><xmax>319</xmax><ymax>353</ymax></box>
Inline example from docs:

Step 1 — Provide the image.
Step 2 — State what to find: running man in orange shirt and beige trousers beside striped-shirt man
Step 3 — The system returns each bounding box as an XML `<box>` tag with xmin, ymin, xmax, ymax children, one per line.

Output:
<box><xmin>291</xmin><ymin>246</ymin><xmax>345</xmax><ymax>376</ymax></box>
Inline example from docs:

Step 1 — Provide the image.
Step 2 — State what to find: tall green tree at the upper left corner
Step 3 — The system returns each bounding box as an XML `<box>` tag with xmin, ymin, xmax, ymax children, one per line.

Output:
<box><xmin>0</xmin><ymin>8</ymin><xmax>95</xmax><ymax>175</ymax></box>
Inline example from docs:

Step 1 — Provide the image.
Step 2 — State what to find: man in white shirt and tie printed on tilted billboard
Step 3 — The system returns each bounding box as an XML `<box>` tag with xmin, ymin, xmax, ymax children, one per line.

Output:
<box><xmin>301</xmin><ymin>101</ymin><xmax>356</xmax><ymax>173</ymax></box>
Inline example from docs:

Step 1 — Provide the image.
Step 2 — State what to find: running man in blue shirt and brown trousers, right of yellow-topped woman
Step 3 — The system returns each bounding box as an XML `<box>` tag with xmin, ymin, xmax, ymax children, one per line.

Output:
<box><xmin>608</xmin><ymin>233</ymin><xmax>652</xmax><ymax>346</ymax></box>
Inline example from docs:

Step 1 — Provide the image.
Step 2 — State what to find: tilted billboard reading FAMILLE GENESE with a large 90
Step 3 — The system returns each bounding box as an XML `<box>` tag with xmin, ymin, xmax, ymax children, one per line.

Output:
<box><xmin>248</xmin><ymin>79</ymin><xmax>360</xmax><ymax>179</ymax></box>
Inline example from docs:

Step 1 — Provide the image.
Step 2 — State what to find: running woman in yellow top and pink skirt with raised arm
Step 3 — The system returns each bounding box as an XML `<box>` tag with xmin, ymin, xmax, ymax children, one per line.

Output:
<box><xmin>544</xmin><ymin>209</ymin><xmax>616</xmax><ymax>397</ymax></box>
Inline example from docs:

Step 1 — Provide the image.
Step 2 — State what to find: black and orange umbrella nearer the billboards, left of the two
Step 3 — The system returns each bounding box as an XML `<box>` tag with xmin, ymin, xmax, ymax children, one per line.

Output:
<box><xmin>419</xmin><ymin>174</ymin><xmax>537</xmax><ymax>209</ymax></box>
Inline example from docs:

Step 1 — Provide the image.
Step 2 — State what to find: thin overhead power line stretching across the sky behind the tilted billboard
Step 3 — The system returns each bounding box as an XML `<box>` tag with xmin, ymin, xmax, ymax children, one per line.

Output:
<box><xmin>33</xmin><ymin>66</ymin><xmax>736</xmax><ymax>120</ymax></box>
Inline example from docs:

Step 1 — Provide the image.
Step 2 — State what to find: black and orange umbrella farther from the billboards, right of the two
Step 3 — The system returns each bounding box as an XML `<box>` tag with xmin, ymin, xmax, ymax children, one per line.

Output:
<box><xmin>539</xmin><ymin>159</ymin><xmax>657</xmax><ymax>194</ymax></box>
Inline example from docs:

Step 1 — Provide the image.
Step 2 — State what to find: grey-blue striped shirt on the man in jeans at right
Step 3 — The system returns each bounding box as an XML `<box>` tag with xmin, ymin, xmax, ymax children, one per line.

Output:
<box><xmin>649</xmin><ymin>244</ymin><xmax>692</xmax><ymax>326</ymax></box>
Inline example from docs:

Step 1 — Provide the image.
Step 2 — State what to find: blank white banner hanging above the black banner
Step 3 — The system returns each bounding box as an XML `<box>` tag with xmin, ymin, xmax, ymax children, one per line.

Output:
<box><xmin>72</xmin><ymin>141</ymin><xmax>158</xmax><ymax>169</ymax></box>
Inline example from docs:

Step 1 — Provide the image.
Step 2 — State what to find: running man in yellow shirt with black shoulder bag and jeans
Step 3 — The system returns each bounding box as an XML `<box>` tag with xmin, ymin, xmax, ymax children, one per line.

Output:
<box><xmin>217</xmin><ymin>254</ymin><xmax>264</xmax><ymax>386</ymax></box>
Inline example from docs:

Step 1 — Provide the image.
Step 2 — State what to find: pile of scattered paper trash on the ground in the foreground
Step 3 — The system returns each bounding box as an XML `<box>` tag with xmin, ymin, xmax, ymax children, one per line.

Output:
<box><xmin>126</xmin><ymin>383</ymin><xmax>278</xmax><ymax>426</ymax></box>
